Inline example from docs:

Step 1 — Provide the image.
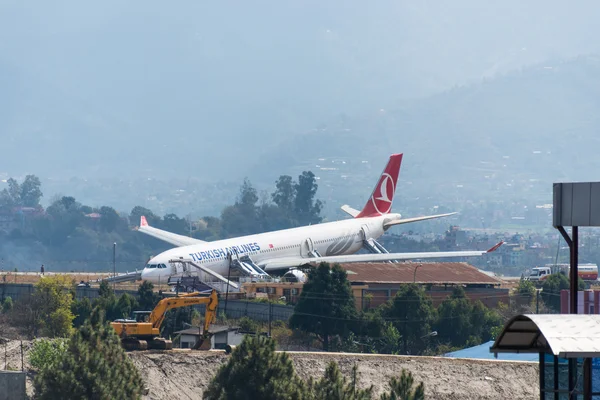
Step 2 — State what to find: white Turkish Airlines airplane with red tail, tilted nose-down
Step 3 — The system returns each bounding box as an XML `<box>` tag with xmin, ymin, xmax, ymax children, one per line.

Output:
<box><xmin>138</xmin><ymin>154</ymin><xmax>503</xmax><ymax>284</ymax></box>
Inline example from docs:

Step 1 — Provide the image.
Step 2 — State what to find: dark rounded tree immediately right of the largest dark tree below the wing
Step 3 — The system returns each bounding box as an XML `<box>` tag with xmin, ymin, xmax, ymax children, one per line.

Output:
<box><xmin>382</xmin><ymin>284</ymin><xmax>436</xmax><ymax>354</ymax></box>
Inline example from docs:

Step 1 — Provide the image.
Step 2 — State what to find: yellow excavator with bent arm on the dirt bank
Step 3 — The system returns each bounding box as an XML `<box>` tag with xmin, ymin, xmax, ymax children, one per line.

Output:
<box><xmin>110</xmin><ymin>290</ymin><xmax>219</xmax><ymax>351</ymax></box>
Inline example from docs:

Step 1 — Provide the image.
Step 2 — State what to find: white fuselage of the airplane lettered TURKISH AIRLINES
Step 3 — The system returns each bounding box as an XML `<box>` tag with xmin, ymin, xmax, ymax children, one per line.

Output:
<box><xmin>142</xmin><ymin>214</ymin><xmax>400</xmax><ymax>283</ymax></box>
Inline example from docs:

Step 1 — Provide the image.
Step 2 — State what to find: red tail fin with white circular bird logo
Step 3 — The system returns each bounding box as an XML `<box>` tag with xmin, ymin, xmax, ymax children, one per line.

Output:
<box><xmin>356</xmin><ymin>154</ymin><xmax>402</xmax><ymax>218</ymax></box>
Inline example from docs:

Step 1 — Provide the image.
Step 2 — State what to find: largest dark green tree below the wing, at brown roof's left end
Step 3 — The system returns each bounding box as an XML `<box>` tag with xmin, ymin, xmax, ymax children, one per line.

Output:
<box><xmin>290</xmin><ymin>263</ymin><xmax>357</xmax><ymax>351</ymax></box>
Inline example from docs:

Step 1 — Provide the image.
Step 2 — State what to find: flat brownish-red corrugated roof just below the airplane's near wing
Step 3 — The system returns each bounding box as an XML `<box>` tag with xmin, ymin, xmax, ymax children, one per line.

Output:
<box><xmin>341</xmin><ymin>262</ymin><xmax>502</xmax><ymax>285</ymax></box>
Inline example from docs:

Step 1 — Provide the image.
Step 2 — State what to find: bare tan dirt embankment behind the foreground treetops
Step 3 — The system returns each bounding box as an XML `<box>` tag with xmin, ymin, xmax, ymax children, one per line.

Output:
<box><xmin>131</xmin><ymin>351</ymin><xmax>539</xmax><ymax>400</ymax></box>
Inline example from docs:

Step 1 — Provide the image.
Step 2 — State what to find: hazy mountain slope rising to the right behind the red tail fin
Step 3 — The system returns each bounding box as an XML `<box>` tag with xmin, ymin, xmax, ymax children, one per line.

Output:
<box><xmin>254</xmin><ymin>56</ymin><xmax>600</xmax><ymax>209</ymax></box>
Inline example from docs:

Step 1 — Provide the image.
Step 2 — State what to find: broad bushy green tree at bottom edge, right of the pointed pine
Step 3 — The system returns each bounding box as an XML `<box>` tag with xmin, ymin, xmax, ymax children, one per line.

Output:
<box><xmin>203</xmin><ymin>336</ymin><xmax>306</xmax><ymax>400</ymax></box>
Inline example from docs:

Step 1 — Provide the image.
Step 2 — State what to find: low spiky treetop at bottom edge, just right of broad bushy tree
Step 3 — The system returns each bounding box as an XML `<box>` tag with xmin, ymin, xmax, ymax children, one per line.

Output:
<box><xmin>305</xmin><ymin>361</ymin><xmax>373</xmax><ymax>400</ymax></box>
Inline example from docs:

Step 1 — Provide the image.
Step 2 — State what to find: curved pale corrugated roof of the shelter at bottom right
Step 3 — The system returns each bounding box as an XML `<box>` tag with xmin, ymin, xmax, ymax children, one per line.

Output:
<box><xmin>490</xmin><ymin>314</ymin><xmax>600</xmax><ymax>358</ymax></box>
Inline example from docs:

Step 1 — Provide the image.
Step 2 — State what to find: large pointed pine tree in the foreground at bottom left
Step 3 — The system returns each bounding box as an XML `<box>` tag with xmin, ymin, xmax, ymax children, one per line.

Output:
<box><xmin>34</xmin><ymin>308</ymin><xmax>143</xmax><ymax>400</ymax></box>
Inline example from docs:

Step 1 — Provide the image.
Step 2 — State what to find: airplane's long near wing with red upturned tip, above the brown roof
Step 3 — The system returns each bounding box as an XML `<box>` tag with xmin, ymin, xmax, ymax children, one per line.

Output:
<box><xmin>259</xmin><ymin>242</ymin><xmax>504</xmax><ymax>272</ymax></box>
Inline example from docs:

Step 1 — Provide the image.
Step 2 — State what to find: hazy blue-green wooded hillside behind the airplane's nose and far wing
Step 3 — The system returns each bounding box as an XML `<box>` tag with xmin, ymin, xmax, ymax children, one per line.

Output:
<box><xmin>0</xmin><ymin>172</ymin><xmax>322</xmax><ymax>272</ymax></box>
